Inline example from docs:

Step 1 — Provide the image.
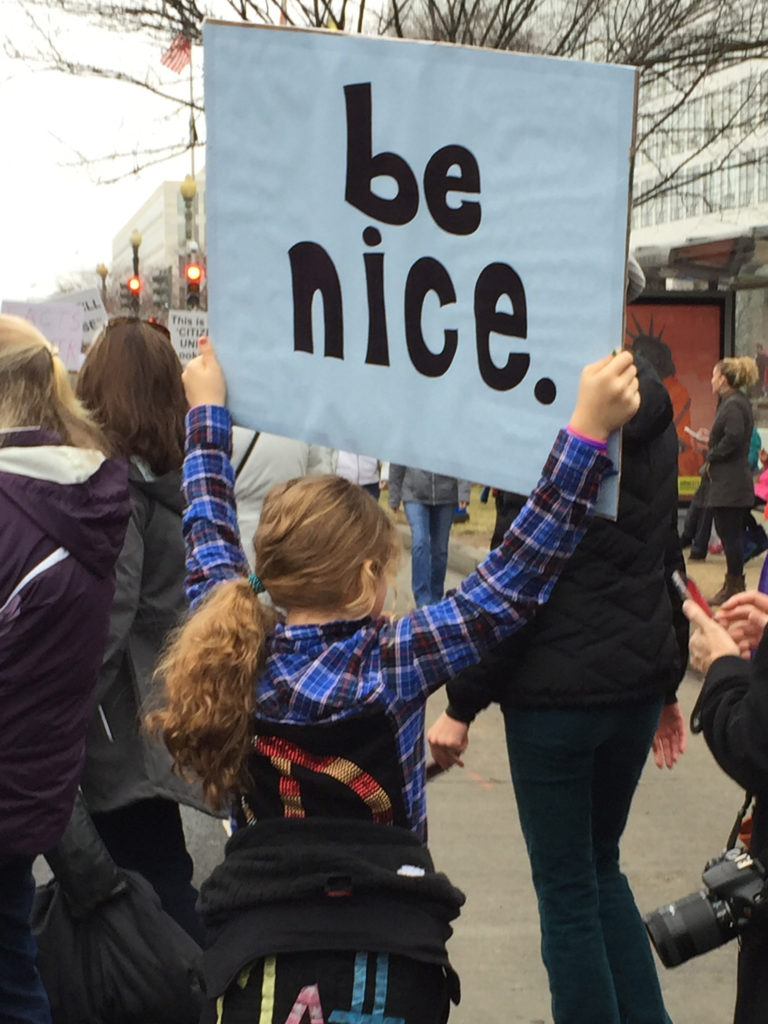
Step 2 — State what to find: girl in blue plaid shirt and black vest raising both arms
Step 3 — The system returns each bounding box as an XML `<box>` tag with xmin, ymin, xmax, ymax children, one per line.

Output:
<box><xmin>150</xmin><ymin>339</ymin><xmax>638</xmax><ymax>1024</ymax></box>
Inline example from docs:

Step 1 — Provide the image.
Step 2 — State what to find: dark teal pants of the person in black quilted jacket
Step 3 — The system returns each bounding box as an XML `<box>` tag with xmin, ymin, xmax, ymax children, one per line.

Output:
<box><xmin>504</xmin><ymin>700</ymin><xmax>671</xmax><ymax>1024</ymax></box>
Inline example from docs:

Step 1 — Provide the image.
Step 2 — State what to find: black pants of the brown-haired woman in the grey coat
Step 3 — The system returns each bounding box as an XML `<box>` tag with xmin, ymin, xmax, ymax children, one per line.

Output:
<box><xmin>91</xmin><ymin>797</ymin><xmax>204</xmax><ymax>945</ymax></box>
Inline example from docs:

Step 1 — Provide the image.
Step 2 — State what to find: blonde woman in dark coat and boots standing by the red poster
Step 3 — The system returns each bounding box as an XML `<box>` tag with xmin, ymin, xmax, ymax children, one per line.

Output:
<box><xmin>701</xmin><ymin>355</ymin><xmax>759</xmax><ymax>604</ymax></box>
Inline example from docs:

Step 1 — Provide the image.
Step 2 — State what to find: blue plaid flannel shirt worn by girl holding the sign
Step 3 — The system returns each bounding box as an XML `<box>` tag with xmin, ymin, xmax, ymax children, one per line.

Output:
<box><xmin>183</xmin><ymin>406</ymin><xmax>612</xmax><ymax>841</ymax></box>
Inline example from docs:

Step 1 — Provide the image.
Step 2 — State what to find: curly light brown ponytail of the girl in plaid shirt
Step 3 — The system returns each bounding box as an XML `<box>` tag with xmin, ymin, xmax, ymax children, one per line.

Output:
<box><xmin>145</xmin><ymin>580</ymin><xmax>278</xmax><ymax>809</ymax></box>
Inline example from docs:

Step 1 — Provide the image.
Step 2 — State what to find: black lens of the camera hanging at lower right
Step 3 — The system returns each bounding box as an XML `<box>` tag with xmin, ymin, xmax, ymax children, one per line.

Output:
<box><xmin>644</xmin><ymin>889</ymin><xmax>737</xmax><ymax>967</ymax></box>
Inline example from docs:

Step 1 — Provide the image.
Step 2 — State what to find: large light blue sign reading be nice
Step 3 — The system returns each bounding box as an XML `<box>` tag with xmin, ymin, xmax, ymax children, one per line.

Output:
<box><xmin>204</xmin><ymin>23</ymin><xmax>636</xmax><ymax>505</ymax></box>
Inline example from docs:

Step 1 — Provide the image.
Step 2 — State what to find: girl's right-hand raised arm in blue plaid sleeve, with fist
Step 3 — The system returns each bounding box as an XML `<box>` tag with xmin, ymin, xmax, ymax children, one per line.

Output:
<box><xmin>380</xmin><ymin>352</ymin><xmax>640</xmax><ymax>701</ymax></box>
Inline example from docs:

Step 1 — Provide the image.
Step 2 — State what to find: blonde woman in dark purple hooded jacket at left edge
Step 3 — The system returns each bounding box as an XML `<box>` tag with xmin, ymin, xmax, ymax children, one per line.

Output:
<box><xmin>0</xmin><ymin>315</ymin><xmax>129</xmax><ymax>1024</ymax></box>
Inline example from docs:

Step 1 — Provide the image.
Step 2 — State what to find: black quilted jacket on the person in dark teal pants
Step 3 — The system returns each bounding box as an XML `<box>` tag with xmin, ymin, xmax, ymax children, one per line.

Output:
<box><xmin>446</xmin><ymin>359</ymin><xmax>688</xmax><ymax>722</ymax></box>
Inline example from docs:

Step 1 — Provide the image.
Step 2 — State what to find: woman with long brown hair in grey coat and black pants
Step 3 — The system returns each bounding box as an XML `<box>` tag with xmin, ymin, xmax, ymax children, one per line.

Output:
<box><xmin>77</xmin><ymin>317</ymin><xmax>210</xmax><ymax>941</ymax></box>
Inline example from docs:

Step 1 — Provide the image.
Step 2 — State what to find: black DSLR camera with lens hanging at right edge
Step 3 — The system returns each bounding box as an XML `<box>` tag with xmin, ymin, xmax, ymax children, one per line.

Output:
<box><xmin>643</xmin><ymin>850</ymin><xmax>768</xmax><ymax>967</ymax></box>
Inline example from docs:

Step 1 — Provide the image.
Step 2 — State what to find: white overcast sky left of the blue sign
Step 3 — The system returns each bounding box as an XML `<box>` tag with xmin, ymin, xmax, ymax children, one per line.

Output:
<box><xmin>0</xmin><ymin>0</ymin><xmax>204</xmax><ymax>300</ymax></box>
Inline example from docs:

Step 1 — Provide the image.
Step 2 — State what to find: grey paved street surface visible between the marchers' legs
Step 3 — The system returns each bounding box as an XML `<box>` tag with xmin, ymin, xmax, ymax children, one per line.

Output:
<box><xmin>174</xmin><ymin>540</ymin><xmax>757</xmax><ymax>1024</ymax></box>
